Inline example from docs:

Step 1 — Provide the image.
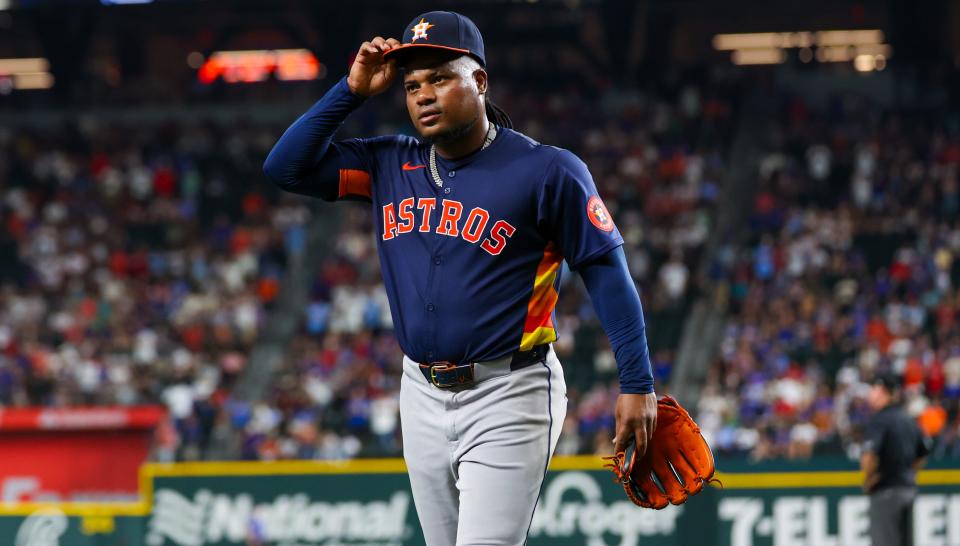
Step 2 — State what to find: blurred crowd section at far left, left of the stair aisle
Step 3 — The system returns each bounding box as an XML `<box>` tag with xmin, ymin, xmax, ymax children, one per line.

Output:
<box><xmin>0</xmin><ymin>123</ymin><xmax>310</xmax><ymax>459</ymax></box>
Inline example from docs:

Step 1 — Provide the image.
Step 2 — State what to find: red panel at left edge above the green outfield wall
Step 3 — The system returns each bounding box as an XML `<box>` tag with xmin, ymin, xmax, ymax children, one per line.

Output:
<box><xmin>0</xmin><ymin>406</ymin><xmax>164</xmax><ymax>503</ymax></box>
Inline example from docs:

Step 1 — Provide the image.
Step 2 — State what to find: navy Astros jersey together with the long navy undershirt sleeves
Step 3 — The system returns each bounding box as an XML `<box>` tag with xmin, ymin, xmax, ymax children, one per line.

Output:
<box><xmin>264</xmin><ymin>78</ymin><xmax>653</xmax><ymax>393</ymax></box>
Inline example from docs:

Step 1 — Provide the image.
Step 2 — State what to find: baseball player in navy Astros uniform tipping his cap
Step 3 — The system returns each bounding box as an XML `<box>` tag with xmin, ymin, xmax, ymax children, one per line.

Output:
<box><xmin>264</xmin><ymin>11</ymin><xmax>657</xmax><ymax>546</ymax></box>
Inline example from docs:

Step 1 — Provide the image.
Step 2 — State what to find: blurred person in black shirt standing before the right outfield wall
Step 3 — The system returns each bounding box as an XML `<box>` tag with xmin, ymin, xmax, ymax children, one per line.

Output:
<box><xmin>860</xmin><ymin>373</ymin><xmax>928</xmax><ymax>546</ymax></box>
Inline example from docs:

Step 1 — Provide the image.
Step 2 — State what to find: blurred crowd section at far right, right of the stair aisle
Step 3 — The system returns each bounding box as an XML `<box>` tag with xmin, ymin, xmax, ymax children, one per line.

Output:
<box><xmin>698</xmin><ymin>97</ymin><xmax>960</xmax><ymax>460</ymax></box>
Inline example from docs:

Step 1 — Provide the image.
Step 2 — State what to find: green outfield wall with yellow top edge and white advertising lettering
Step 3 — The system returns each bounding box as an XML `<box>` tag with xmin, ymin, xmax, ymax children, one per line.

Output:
<box><xmin>0</xmin><ymin>457</ymin><xmax>960</xmax><ymax>546</ymax></box>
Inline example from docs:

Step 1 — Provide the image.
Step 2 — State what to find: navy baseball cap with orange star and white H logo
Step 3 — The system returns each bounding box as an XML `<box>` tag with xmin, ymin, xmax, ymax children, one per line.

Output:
<box><xmin>383</xmin><ymin>11</ymin><xmax>487</xmax><ymax>66</ymax></box>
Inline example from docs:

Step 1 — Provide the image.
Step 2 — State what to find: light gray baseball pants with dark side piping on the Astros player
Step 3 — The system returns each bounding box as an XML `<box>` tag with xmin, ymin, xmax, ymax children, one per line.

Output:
<box><xmin>400</xmin><ymin>347</ymin><xmax>567</xmax><ymax>546</ymax></box>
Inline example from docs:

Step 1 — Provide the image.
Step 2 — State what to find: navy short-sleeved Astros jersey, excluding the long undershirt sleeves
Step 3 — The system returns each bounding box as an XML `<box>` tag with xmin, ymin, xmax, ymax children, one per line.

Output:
<box><xmin>335</xmin><ymin>128</ymin><xmax>623</xmax><ymax>362</ymax></box>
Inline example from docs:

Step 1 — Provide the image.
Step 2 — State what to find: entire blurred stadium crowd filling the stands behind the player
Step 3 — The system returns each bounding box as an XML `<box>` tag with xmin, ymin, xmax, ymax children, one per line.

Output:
<box><xmin>0</xmin><ymin>79</ymin><xmax>960</xmax><ymax>460</ymax></box>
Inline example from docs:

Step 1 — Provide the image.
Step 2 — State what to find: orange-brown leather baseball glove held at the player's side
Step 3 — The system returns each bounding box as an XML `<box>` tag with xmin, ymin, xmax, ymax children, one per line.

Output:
<box><xmin>604</xmin><ymin>396</ymin><xmax>717</xmax><ymax>510</ymax></box>
